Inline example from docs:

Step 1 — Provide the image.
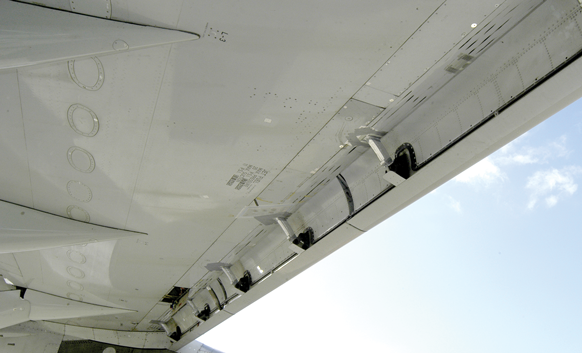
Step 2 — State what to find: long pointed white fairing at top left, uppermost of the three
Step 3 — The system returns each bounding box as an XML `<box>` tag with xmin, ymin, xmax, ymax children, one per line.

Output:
<box><xmin>0</xmin><ymin>0</ymin><xmax>199</xmax><ymax>70</ymax></box>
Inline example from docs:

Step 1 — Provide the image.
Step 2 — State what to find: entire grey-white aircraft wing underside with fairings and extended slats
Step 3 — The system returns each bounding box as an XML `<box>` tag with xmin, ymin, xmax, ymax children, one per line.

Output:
<box><xmin>0</xmin><ymin>0</ymin><xmax>582</xmax><ymax>352</ymax></box>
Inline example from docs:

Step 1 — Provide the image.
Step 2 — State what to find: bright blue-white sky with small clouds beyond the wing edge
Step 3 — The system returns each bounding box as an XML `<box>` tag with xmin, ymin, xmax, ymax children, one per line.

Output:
<box><xmin>185</xmin><ymin>100</ymin><xmax>582</xmax><ymax>353</ymax></box>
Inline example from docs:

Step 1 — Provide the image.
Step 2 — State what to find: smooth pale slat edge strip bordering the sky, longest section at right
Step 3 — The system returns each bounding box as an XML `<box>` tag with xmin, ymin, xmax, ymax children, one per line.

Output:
<box><xmin>350</xmin><ymin>52</ymin><xmax>582</xmax><ymax>230</ymax></box>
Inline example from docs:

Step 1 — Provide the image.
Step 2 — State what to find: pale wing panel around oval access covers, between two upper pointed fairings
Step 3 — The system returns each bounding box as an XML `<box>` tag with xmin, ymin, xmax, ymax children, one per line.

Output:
<box><xmin>19</xmin><ymin>47</ymin><xmax>169</xmax><ymax>228</ymax></box>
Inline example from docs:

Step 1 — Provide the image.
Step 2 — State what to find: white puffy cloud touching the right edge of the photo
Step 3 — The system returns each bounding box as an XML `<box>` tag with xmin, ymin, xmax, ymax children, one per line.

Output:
<box><xmin>525</xmin><ymin>166</ymin><xmax>582</xmax><ymax>209</ymax></box>
